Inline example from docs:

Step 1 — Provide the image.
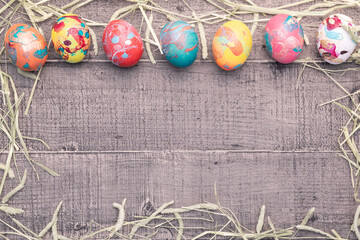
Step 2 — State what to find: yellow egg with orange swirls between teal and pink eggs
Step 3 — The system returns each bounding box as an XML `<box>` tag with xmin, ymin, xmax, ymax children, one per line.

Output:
<box><xmin>212</xmin><ymin>20</ymin><xmax>252</xmax><ymax>71</ymax></box>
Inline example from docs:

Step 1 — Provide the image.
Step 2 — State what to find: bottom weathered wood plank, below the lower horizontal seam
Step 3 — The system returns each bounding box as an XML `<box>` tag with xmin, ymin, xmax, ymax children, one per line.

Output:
<box><xmin>2</xmin><ymin>151</ymin><xmax>356</xmax><ymax>237</ymax></box>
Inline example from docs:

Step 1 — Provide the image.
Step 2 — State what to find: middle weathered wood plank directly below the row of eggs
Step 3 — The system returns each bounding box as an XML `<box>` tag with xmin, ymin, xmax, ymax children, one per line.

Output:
<box><xmin>3</xmin><ymin>63</ymin><xmax>352</xmax><ymax>151</ymax></box>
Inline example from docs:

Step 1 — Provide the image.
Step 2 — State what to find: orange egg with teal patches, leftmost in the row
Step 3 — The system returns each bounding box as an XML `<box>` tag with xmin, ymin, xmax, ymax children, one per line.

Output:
<box><xmin>5</xmin><ymin>23</ymin><xmax>48</xmax><ymax>71</ymax></box>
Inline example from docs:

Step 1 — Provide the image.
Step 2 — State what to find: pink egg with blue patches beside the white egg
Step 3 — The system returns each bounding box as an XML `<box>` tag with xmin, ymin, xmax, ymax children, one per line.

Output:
<box><xmin>264</xmin><ymin>14</ymin><xmax>304</xmax><ymax>64</ymax></box>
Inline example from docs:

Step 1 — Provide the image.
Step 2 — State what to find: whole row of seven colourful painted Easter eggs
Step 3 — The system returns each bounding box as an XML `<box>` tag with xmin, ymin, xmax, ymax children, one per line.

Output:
<box><xmin>5</xmin><ymin>14</ymin><xmax>356</xmax><ymax>71</ymax></box>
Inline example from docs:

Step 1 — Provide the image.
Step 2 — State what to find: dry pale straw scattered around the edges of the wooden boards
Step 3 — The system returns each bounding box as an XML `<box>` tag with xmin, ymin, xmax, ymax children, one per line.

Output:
<box><xmin>0</xmin><ymin>0</ymin><xmax>360</xmax><ymax>240</ymax></box>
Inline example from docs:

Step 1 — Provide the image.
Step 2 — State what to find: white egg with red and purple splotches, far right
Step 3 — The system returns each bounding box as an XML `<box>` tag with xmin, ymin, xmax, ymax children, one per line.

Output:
<box><xmin>316</xmin><ymin>14</ymin><xmax>356</xmax><ymax>64</ymax></box>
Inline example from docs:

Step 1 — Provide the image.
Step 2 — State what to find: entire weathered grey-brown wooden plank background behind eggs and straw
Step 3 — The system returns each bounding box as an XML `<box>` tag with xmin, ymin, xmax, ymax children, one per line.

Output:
<box><xmin>0</xmin><ymin>0</ymin><xmax>360</xmax><ymax>239</ymax></box>
